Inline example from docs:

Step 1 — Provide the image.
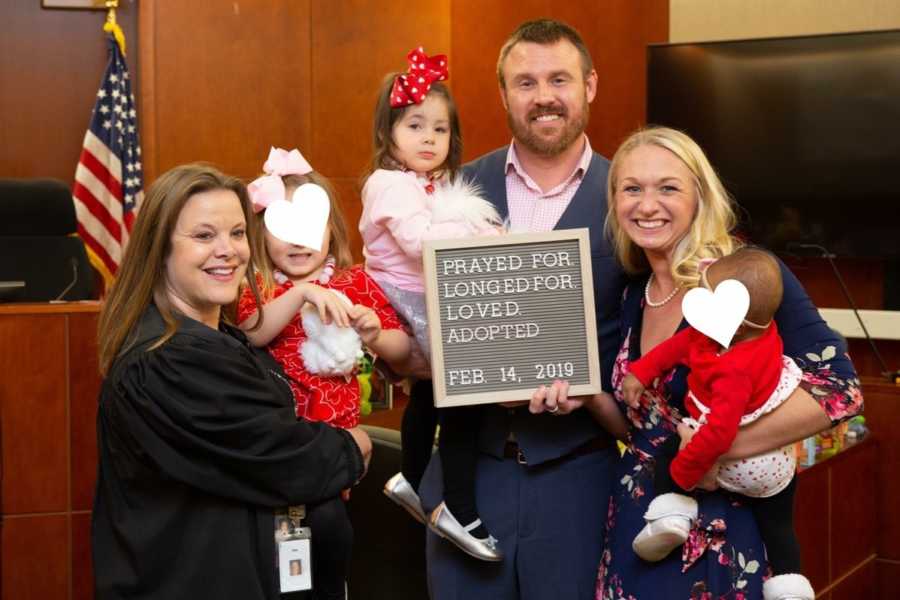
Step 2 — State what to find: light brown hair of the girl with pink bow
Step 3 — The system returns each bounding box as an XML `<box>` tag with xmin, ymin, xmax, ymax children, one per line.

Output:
<box><xmin>250</xmin><ymin>171</ymin><xmax>353</xmax><ymax>298</ymax></box>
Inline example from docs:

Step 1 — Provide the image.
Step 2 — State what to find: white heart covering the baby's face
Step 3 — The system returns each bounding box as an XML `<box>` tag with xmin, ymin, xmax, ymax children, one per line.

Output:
<box><xmin>681</xmin><ymin>279</ymin><xmax>750</xmax><ymax>348</ymax></box>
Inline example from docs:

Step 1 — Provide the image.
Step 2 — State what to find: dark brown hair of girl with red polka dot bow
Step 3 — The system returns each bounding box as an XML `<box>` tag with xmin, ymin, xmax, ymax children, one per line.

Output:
<box><xmin>366</xmin><ymin>73</ymin><xmax>462</xmax><ymax>180</ymax></box>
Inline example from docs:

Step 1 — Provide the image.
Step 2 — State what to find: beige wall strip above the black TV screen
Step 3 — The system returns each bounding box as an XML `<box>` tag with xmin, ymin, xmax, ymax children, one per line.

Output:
<box><xmin>669</xmin><ymin>0</ymin><xmax>900</xmax><ymax>43</ymax></box>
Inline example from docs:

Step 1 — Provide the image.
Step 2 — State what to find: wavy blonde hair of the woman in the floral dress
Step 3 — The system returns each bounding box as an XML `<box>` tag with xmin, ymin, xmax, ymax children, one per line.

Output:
<box><xmin>606</xmin><ymin>127</ymin><xmax>742</xmax><ymax>287</ymax></box>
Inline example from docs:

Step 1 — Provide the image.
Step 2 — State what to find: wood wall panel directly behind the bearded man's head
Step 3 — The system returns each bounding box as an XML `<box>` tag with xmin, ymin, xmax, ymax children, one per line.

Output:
<box><xmin>451</xmin><ymin>0</ymin><xmax>669</xmax><ymax>158</ymax></box>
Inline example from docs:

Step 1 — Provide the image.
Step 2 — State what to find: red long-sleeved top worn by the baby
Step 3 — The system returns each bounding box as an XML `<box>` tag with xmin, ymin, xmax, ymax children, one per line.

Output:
<box><xmin>630</xmin><ymin>322</ymin><xmax>784</xmax><ymax>490</ymax></box>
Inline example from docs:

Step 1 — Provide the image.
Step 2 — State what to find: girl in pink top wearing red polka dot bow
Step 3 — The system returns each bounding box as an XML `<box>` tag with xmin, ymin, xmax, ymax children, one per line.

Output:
<box><xmin>359</xmin><ymin>48</ymin><xmax>502</xmax><ymax>561</ymax></box>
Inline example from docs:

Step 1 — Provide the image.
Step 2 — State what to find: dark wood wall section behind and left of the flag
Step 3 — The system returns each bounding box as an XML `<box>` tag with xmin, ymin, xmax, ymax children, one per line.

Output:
<box><xmin>0</xmin><ymin>0</ymin><xmax>139</xmax><ymax>184</ymax></box>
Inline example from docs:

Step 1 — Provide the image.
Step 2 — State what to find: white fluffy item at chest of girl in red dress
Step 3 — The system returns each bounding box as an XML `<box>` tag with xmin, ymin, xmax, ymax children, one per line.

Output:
<box><xmin>300</xmin><ymin>290</ymin><xmax>363</xmax><ymax>377</ymax></box>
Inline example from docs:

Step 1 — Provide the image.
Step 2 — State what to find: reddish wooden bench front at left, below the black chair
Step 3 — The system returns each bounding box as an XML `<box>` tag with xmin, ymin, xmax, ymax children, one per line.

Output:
<box><xmin>0</xmin><ymin>302</ymin><xmax>101</xmax><ymax>600</ymax></box>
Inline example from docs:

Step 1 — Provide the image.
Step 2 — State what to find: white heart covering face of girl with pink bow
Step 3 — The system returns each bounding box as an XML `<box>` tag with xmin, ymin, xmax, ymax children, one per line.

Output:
<box><xmin>264</xmin><ymin>183</ymin><xmax>331</xmax><ymax>251</ymax></box>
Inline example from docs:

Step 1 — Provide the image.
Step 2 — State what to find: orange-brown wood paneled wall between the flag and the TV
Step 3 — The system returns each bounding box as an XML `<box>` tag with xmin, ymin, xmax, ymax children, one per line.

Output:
<box><xmin>140</xmin><ymin>0</ymin><xmax>668</xmax><ymax>258</ymax></box>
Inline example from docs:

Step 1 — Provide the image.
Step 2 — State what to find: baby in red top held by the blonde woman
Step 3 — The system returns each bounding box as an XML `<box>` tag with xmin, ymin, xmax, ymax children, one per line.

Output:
<box><xmin>622</xmin><ymin>248</ymin><xmax>814</xmax><ymax>600</ymax></box>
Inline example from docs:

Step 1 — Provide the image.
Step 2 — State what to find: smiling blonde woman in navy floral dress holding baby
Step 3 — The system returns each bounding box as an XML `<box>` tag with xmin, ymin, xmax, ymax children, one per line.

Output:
<box><xmin>532</xmin><ymin>128</ymin><xmax>862</xmax><ymax>600</ymax></box>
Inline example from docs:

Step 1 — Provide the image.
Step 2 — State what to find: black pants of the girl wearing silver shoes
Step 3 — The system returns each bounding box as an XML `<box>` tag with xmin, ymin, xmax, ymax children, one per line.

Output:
<box><xmin>400</xmin><ymin>380</ymin><xmax>482</xmax><ymax>512</ymax></box>
